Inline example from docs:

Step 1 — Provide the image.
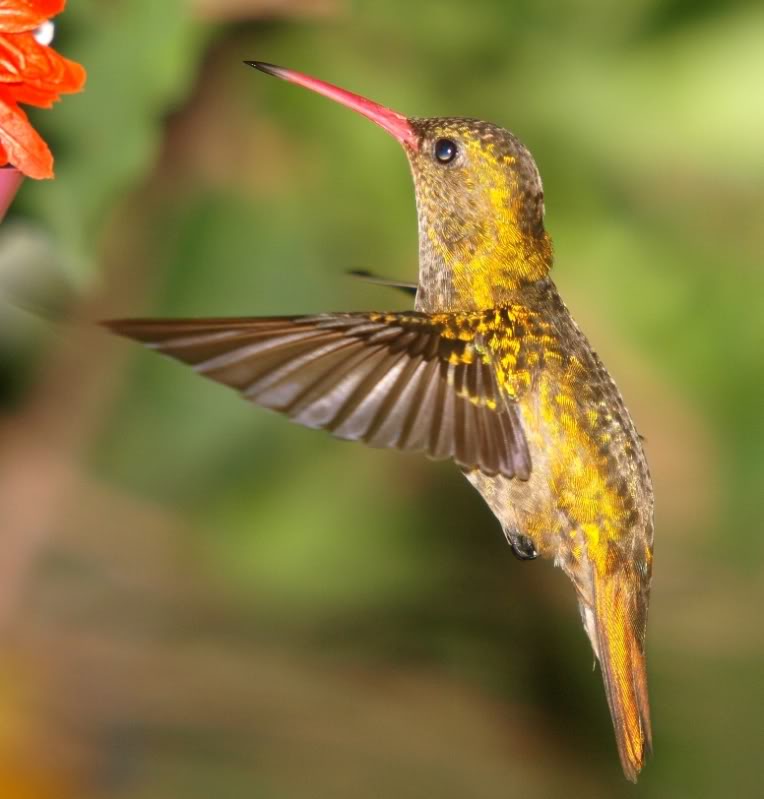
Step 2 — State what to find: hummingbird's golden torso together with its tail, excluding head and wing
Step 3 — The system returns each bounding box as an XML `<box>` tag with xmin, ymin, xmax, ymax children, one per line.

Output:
<box><xmin>417</xmin><ymin>278</ymin><xmax>653</xmax><ymax>781</ymax></box>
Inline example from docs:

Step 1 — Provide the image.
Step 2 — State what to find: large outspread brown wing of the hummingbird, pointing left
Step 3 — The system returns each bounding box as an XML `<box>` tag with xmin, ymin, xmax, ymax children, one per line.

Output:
<box><xmin>104</xmin><ymin>311</ymin><xmax>531</xmax><ymax>480</ymax></box>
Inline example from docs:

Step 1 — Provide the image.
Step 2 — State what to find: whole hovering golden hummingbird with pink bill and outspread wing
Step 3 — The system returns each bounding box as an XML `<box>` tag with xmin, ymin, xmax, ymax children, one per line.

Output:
<box><xmin>104</xmin><ymin>61</ymin><xmax>653</xmax><ymax>782</ymax></box>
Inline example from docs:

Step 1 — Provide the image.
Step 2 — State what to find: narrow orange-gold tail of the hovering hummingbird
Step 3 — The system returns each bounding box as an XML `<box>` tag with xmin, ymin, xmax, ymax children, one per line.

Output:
<box><xmin>584</xmin><ymin>573</ymin><xmax>652</xmax><ymax>782</ymax></box>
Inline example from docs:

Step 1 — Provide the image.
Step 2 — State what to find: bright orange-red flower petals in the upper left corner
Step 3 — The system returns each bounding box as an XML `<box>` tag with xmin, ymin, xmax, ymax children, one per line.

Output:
<box><xmin>0</xmin><ymin>0</ymin><xmax>85</xmax><ymax>178</ymax></box>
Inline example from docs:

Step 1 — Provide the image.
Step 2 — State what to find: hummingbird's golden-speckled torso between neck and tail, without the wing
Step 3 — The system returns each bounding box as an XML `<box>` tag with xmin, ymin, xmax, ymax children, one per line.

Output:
<box><xmin>456</xmin><ymin>281</ymin><xmax>653</xmax><ymax>577</ymax></box>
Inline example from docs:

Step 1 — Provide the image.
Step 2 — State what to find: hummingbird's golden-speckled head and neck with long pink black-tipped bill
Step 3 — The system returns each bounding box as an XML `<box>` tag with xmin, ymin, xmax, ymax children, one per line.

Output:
<box><xmin>246</xmin><ymin>61</ymin><xmax>552</xmax><ymax>311</ymax></box>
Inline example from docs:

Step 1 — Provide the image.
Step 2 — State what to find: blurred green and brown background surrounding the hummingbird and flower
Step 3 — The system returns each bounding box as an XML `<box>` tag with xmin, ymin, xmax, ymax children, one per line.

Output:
<box><xmin>0</xmin><ymin>0</ymin><xmax>764</xmax><ymax>799</ymax></box>
